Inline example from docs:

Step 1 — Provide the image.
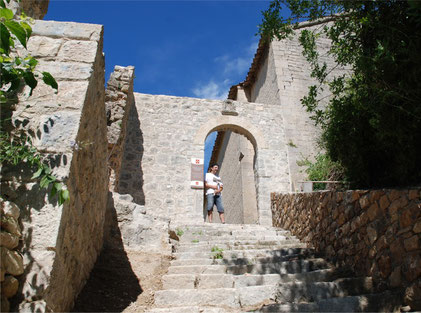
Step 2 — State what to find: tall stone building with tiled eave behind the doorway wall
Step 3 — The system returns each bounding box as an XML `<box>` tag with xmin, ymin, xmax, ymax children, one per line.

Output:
<box><xmin>228</xmin><ymin>28</ymin><xmax>349</xmax><ymax>191</ymax></box>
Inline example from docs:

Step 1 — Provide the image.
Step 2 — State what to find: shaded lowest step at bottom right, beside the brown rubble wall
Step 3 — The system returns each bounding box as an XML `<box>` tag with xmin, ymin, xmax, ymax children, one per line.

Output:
<box><xmin>254</xmin><ymin>292</ymin><xmax>402</xmax><ymax>313</ymax></box>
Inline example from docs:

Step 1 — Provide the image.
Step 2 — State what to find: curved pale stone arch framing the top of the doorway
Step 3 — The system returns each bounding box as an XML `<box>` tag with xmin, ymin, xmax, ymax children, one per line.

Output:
<box><xmin>194</xmin><ymin>115</ymin><xmax>268</xmax><ymax>150</ymax></box>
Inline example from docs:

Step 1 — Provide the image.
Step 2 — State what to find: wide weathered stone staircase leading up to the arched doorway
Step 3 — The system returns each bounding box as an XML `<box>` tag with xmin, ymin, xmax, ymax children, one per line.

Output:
<box><xmin>148</xmin><ymin>224</ymin><xmax>400</xmax><ymax>313</ymax></box>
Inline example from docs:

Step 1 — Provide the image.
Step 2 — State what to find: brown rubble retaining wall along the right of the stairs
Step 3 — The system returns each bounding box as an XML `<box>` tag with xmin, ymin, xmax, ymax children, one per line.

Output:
<box><xmin>272</xmin><ymin>188</ymin><xmax>421</xmax><ymax>310</ymax></box>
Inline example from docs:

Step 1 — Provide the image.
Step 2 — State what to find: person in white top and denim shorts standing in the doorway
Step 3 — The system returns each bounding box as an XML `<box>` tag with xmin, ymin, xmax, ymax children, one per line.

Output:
<box><xmin>205</xmin><ymin>163</ymin><xmax>225</xmax><ymax>224</ymax></box>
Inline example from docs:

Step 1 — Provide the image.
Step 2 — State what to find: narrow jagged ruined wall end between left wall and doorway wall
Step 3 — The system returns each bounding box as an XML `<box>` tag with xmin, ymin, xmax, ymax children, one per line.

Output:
<box><xmin>105</xmin><ymin>66</ymin><xmax>134</xmax><ymax>191</ymax></box>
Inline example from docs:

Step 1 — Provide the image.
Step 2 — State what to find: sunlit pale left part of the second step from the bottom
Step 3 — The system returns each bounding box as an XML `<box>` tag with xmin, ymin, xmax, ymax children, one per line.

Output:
<box><xmin>155</xmin><ymin>285</ymin><xmax>276</xmax><ymax>312</ymax></box>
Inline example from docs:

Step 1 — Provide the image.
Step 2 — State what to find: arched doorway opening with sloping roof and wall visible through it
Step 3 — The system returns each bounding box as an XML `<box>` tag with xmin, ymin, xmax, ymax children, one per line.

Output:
<box><xmin>204</xmin><ymin>125</ymin><xmax>258</xmax><ymax>224</ymax></box>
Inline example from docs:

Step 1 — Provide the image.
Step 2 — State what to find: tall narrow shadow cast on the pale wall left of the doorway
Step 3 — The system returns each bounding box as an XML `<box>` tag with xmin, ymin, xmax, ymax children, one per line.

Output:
<box><xmin>117</xmin><ymin>103</ymin><xmax>145</xmax><ymax>205</ymax></box>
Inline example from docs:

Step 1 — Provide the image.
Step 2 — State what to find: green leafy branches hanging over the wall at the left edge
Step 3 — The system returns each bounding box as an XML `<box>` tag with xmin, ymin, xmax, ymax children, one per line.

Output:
<box><xmin>0</xmin><ymin>0</ymin><xmax>69</xmax><ymax>204</ymax></box>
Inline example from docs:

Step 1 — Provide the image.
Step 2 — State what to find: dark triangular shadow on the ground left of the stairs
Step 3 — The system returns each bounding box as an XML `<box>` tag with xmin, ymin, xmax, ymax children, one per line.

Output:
<box><xmin>71</xmin><ymin>195</ymin><xmax>143</xmax><ymax>312</ymax></box>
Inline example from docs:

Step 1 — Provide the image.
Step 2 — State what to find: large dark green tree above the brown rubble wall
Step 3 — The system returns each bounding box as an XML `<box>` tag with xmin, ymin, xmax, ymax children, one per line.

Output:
<box><xmin>260</xmin><ymin>0</ymin><xmax>421</xmax><ymax>188</ymax></box>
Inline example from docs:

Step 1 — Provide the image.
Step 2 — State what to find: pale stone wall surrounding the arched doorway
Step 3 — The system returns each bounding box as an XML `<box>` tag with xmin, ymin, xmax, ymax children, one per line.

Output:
<box><xmin>119</xmin><ymin>93</ymin><xmax>289</xmax><ymax>225</ymax></box>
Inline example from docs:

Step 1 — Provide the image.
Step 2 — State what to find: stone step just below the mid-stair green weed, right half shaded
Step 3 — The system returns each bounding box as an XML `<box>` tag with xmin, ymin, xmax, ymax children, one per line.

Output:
<box><xmin>168</xmin><ymin>258</ymin><xmax>329</xmax><ymax>275</ymax></box>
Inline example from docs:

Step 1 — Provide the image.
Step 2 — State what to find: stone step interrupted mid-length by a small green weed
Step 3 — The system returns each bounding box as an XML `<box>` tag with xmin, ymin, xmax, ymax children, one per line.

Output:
<box><xmin>173</xmin><ymin>243</ymin><xmax>307</xmax><ymax>260</ymax></box>
